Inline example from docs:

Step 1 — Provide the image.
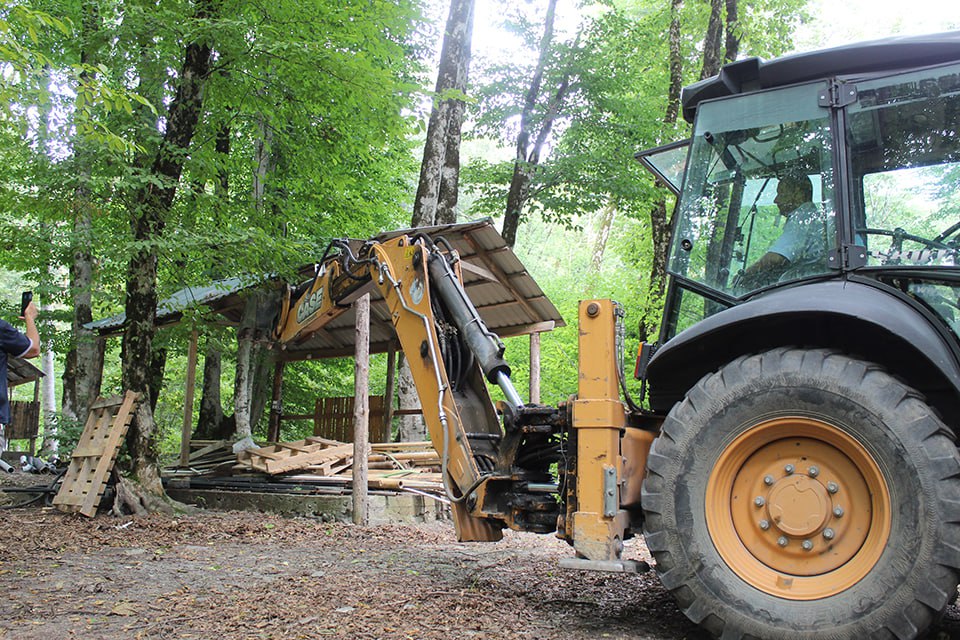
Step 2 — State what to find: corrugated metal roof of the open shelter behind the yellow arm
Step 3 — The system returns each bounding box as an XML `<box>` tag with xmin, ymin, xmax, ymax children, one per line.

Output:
<box><xmin>86</xmin><ymin>218</ymin><xmax>565</xmax><ymax>360</ymax></box>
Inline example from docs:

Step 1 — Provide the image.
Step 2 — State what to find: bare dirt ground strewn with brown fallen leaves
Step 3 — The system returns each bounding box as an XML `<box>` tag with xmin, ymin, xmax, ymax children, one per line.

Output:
<box><xmin>0</xmin><ymin>472</ymin><xmax>960</xmax><ymax>640</ymax></box>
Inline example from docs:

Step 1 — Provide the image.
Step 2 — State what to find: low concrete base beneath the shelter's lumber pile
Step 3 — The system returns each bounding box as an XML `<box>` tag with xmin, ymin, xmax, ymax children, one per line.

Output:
<box><xmin>167</xmin><ymin>486</ymin><xmax>450</xmax><ymax>525</ymax></box>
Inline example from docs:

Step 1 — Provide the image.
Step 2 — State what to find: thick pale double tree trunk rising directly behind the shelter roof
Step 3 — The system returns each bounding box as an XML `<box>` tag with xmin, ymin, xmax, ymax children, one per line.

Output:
<box><xmin>411</xmin><ymin>0</ymin><xmax>474</xmax><ymax>227</ymax></box>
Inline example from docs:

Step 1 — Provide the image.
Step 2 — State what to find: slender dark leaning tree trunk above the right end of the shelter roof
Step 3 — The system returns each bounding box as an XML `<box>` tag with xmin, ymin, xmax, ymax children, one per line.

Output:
<box><xmin>500</xmin><ymin>0</ymin><xmax>566</xmax><ymax>247</ymax></box>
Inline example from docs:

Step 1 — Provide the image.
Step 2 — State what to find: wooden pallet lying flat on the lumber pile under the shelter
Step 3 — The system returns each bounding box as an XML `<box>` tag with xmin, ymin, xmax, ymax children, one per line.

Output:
<box><xmin>237</xmin><ymin>436</ymin><xmax>364</xmax><ymax>475</ymax></box>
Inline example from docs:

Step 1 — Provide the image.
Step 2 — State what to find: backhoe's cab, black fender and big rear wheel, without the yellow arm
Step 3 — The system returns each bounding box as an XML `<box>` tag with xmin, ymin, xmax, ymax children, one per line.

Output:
<box><xmin>640</xmin><ymin>32</ymin><xmax>960</xmax><ymax>640</ymax></box>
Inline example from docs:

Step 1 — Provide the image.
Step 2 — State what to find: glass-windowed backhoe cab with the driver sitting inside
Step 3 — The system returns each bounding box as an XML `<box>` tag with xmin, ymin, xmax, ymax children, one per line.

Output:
<box><xmin>639</xmin><ymin>34</ymin><xmax>960</xmax><ymax>342</ymax></box>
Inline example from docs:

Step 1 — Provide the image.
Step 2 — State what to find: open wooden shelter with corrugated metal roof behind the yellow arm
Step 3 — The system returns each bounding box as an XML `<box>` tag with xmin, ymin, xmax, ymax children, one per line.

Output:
<box><xmin>87</xmin><ymin>219</ymin><xmax>564</xmax><ymax>460</ymax></box>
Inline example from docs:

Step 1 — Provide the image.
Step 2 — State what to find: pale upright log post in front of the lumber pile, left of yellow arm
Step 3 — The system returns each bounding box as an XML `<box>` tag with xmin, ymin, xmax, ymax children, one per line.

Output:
<box><xmin>353</xmin><ymin>294</ymin><xmax>370</xmax><ymax>525</ymax></box>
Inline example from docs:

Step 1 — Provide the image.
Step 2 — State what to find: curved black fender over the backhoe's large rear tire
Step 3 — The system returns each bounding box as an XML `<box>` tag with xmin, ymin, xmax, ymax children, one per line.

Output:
<box><xmin>645</xmin><ymin>280</ymin><xmax>960</xmax><ymax>424</ymax></box>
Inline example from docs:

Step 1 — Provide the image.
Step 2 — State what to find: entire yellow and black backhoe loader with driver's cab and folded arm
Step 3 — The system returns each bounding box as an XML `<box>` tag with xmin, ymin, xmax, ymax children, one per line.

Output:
<box><xmin>278</xmin><ymin>32</ymin><xmax>960</xmax><ymax>639</ymax></box>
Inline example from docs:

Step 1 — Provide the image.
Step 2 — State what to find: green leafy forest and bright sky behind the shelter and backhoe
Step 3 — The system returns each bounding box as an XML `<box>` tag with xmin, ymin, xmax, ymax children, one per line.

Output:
<box><xmin>0</xmin><ymin>0</ymin><xmax>960</xmax><ymax>500</ymax></box>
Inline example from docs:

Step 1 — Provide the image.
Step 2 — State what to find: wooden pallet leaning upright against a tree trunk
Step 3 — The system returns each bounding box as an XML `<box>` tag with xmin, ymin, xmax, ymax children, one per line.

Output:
<box><xmin>53</xmin><ymin>391</ymin><xmax>139</xmax><ymax>517</ymax></box>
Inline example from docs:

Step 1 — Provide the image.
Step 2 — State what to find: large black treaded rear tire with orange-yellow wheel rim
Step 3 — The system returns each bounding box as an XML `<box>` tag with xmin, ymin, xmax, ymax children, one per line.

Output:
<box><xmin>642</xmin><ymin>348</ymin><xmax>960</xmax><ymax>639</ymax></box>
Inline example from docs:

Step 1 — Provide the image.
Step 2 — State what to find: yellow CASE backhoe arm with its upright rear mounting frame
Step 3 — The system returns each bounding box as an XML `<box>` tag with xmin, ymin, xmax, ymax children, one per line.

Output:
<box><xmin>277</xmin><ymin>228</ymin><xmax>650</xmax><ymax>570</ymax></box>
